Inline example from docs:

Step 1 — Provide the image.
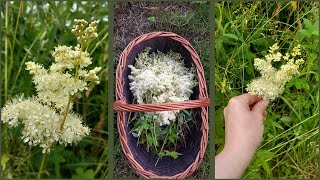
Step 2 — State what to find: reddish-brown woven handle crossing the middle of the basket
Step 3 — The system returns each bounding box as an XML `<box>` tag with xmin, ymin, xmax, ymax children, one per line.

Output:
<box><xmin>113</xmin><ymin>98</ymin><xmax>210</xmax><ymax>112</ymax></box>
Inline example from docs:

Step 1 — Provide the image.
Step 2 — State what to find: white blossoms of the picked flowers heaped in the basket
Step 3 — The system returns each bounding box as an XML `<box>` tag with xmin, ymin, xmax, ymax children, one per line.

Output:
<box><xmin>128</xmin><ymin>48</ymin><xmax>197</xmax><ymax>126</ymax></box>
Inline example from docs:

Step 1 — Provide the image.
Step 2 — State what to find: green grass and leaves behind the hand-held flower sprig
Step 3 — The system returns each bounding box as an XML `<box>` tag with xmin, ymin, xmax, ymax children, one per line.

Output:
<box><xmin>215</xmin><ymin>1</ymin><xmax>319</xmax><ymax>178</ymax></box>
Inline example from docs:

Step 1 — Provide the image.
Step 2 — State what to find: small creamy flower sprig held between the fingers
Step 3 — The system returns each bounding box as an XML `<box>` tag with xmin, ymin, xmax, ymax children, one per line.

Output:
<box><xmin>247</xmin><ymin>44</ymin><xmax>304</xmax><ymax>100</ymax></box>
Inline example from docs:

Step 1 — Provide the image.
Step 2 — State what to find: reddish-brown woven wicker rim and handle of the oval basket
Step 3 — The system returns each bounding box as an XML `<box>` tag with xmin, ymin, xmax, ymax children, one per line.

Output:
<box><xmin>114</xmin><ymin>32</ymin><xmax>210</xmax><ymax>179</ymax></box>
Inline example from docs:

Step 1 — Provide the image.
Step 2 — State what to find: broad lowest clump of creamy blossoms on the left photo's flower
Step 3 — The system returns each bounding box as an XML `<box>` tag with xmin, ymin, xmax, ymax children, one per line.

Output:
<box><xmin>1</xmin><ymin>97</ymin><xmax>90</xmax><ymax>153</ymax></box>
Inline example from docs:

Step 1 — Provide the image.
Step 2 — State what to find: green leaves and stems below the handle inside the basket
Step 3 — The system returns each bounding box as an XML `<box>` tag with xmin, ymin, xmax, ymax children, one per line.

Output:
<box><xmin>130</xmin><ymin>110</ymin><xmax>194</xmax><ymax>162</ymax></box>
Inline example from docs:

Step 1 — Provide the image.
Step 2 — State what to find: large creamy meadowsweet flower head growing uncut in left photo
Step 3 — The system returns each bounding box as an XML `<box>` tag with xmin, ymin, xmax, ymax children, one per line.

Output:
<box><xmin>1</xmin><ymin>19</ymin><xmax>101</xmax><ymax>153</ymax></box>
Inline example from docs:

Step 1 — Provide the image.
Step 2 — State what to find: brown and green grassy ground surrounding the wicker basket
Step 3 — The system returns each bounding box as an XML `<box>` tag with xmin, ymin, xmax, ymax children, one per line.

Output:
<box><xmin>114</xmin><ymin>2</ymin><xmax>210</xmax><ymax>179</ymax></box>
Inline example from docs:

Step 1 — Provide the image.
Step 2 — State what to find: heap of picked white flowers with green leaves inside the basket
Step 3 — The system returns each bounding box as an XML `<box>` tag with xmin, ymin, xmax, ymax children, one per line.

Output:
<box><xmin>128</xmin><ymin>48</ymin><xmax>197</xmax><ymax>158</ymax></box>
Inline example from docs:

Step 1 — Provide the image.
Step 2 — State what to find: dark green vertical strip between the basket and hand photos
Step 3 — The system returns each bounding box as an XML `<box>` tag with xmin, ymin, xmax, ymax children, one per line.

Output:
<box><xmin>209</xmin><ymin>0</ymin><xmax>215</xmax><ymax>179</ymax></box>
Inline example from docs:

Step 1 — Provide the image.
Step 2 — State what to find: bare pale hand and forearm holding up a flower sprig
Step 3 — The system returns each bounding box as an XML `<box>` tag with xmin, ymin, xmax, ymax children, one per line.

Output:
<box><xmin>215</xmin><ymin>94</ymin><xmax>269</xmax><ymax>179</ymax></box>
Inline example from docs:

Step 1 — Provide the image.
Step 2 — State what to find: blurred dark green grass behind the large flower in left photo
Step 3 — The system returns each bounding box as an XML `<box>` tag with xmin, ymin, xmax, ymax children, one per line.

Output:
<box><xmin>0</xmin><ymin>1</ymin><xmax>108</xmax><ymax>178</ymax></box>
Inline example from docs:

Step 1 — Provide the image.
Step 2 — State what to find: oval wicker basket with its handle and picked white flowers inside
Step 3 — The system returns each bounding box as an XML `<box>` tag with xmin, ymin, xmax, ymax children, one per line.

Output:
<box><xmin>114</xmin><ymin>32</ymin><xmax>210</xmax><ymax>178</ymax></box>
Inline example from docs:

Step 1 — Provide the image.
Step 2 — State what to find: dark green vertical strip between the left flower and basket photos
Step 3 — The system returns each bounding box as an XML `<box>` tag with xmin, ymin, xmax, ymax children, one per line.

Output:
<box><xmin>108</xmin><ymin>0</ymin><xmax>114</xmax><ymax>179</ymax></box>
